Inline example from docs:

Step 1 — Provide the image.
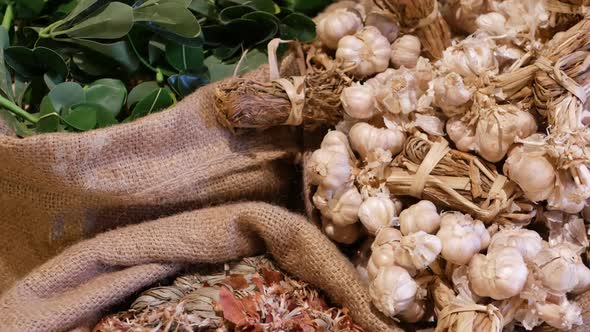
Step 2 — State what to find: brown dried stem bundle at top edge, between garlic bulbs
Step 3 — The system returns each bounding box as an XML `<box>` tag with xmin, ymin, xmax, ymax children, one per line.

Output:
<box><xmin>375</xmin><ymin>0</ymin><xmax>451</xmax><ymax>60</ymax></box>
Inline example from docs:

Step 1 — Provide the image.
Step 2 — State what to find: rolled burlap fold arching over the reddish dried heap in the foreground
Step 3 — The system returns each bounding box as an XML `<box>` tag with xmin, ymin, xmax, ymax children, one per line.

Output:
<box><xmin>0</xmin><ymin>203</ymin><xmax>399</xmax><ymax>332</ymax></box>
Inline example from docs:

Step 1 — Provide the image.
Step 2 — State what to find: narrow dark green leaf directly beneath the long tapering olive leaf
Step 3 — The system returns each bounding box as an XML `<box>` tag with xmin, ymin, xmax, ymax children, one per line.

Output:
<box><xmin>60</xmin><ymin>38</ymin><xmax>139</xmax><ymax>72</ymax></box>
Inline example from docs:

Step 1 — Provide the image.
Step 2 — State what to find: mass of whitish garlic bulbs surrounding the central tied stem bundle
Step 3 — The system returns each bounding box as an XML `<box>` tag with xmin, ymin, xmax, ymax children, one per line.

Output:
<box><xmin>306</xmin><ymin>0</ymin><xmax>590</xmax><ymax>330</ymax></box>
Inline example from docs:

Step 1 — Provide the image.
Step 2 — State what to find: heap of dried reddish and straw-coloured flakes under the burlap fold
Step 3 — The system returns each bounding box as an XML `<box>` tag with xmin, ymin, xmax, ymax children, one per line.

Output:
<box><xmin>93</xmin><ymin>257</ymin><xmax>362</xmax><ymax>332</ymax></box>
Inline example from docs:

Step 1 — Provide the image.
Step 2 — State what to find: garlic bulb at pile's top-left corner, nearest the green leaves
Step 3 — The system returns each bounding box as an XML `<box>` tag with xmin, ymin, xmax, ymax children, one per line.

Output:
<box><xmin>316</xmin><ymin>8</ymin><xmax>363</xmax><ymax>49</ymax></box>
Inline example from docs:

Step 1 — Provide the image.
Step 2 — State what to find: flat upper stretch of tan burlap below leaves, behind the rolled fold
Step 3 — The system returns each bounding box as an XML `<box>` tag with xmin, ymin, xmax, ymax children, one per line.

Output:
<box><xmin>0</xmin><ymin>70</ymin><xmax>301</xmax><ymax>294</ymax></box>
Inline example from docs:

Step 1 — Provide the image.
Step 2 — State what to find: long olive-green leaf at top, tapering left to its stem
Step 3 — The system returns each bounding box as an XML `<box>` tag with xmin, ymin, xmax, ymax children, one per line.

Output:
<box><xmin>52</xmin><ymin>2</ymin><xmax>133</xmax><ymax>39</ymax></box>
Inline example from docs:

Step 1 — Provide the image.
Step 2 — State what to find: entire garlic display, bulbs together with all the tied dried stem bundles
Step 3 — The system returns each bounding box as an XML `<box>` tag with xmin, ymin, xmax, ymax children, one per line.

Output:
<box><xmin>216</xmin><ymin>0</ymin><xmax>590</xmax><ymax>331</ymax></box>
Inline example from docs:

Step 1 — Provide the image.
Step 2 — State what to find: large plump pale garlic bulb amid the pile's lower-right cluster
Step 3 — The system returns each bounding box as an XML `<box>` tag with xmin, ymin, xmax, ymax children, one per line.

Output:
<box><xmin>469</xmin><ymin>247</ymin><xmax>529</xmax><ymax>300</ymax></box>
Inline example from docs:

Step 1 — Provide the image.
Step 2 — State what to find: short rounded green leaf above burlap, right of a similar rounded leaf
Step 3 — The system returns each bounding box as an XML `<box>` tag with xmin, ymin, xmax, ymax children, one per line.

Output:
<box><xmin>86</xmin><ymin>79</ymin><xmax>127</xmax><ymax>117</ymax></box>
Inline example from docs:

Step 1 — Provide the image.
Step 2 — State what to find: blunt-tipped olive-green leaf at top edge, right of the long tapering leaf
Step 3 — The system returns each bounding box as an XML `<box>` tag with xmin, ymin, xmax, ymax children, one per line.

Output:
<box><xmin>133</xmin><ymin>2</ymin><xmax>201</xmax><ymax>38</ymax></box>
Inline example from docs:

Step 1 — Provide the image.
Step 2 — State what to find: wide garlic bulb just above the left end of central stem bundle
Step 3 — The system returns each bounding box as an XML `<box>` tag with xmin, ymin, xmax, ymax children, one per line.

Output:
<box><xmin>349</xmin><ymin>122</ymin><xmax>406</xmax><ymax>159</ymax></box>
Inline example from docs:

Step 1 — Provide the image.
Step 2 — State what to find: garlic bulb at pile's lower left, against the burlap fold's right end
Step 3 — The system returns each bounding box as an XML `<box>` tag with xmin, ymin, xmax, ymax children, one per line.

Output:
<box><xmin>369</xmin><ymin>266</ymin><xmax>418</xmax><ymax>317</ymax></box>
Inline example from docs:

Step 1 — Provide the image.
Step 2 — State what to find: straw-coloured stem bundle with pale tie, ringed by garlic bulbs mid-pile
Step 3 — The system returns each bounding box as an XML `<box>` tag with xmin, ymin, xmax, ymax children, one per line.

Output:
<box><xmin>387</xmin><ymin>134</ymin><xmax>535</xmax><ymax>224</ymax></box>
